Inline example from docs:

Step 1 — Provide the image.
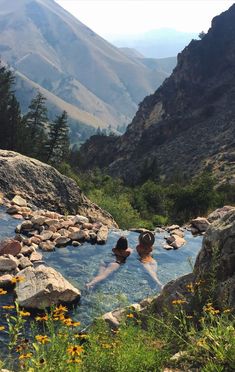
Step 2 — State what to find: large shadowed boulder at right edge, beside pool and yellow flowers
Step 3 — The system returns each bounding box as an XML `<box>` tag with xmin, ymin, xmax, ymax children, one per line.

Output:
<box><xmin>151</xmin><ymin>208</ymin><xmax>235</xmax><ymax>312</ymax></box>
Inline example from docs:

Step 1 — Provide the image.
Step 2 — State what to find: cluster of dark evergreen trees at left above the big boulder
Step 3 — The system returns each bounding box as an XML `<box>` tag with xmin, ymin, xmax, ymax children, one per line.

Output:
<box><xmin>0</xmin><ymin>62</ymin><xmax>70</xmax><ymax>165</ymax></box>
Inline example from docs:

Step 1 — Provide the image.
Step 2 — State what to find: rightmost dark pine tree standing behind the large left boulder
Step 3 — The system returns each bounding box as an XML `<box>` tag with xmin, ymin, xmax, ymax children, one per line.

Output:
<box><xmin>46</xmin><ymin>111</ymin><xmax>69</xmax><ymax>164</ymax></box>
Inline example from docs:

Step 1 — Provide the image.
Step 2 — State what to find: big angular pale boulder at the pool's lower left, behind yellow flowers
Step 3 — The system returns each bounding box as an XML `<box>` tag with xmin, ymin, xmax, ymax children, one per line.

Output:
<box><xmin>15</xmin><ymin>265</ymin><xmax>80</xmax><ymax>309</ymax></box>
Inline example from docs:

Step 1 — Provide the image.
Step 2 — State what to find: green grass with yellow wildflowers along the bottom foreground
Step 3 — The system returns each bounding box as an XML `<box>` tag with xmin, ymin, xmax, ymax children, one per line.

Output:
<box><xmin>0</xmin><ymin>282</ymin><xmax>235</xmax><ymax>372</ymax></box>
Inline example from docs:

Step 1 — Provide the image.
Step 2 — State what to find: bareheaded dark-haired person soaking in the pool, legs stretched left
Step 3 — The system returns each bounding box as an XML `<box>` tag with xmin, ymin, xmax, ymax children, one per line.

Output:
<box><xmin>86</xmin><ymin>236</ymin><xmax>132</xmax><ymax>288</ymax></box>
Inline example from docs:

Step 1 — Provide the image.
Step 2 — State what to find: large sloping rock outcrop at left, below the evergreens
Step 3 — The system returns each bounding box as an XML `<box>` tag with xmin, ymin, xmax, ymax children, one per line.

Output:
<box><xmin>0</xmin><ymin>150</ymin><xmax>117</xmax><ymax>227</ymax></box>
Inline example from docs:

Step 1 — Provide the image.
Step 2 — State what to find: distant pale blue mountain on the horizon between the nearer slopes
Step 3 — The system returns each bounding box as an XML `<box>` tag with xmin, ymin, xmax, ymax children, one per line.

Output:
<box><xmin>111</xmin><ymin>28</ymin><xmax>198</xmax><ymax>58</ymax></box>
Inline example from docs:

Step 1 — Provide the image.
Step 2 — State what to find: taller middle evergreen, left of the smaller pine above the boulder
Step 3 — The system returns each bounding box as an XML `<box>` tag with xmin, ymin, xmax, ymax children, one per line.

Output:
<box><xmin>24</xmin><ymin>92</ymin><xmax>48</xmax><ymax>160</ymax></box>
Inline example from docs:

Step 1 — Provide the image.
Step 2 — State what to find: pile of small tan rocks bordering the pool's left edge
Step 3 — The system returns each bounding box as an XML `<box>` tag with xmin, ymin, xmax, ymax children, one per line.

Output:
<box><xmin>4</xmin><ymin>195</ymin><xmax>108</xmax><ymax>255</ymax></box>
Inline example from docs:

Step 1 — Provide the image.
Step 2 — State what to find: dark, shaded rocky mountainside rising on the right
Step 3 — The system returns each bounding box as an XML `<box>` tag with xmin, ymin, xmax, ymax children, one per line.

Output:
<box><xmin>81</xmin><ymin>4</ymin><xmax>235</xmax><ymax>184</ymax></box>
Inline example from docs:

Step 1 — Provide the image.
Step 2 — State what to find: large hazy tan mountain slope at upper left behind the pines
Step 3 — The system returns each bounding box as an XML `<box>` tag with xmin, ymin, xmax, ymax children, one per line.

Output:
<box><xmin>0</xmin><ymin>0</ymin><xmax>174</xmax><ymax>139</ymax></box>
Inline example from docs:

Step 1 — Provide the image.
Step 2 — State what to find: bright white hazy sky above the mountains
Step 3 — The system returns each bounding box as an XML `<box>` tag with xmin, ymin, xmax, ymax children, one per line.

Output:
<box><xmin>56</xmin><ymin>0</ymin><xmax>234</xmax><ymax>39</ymax></box>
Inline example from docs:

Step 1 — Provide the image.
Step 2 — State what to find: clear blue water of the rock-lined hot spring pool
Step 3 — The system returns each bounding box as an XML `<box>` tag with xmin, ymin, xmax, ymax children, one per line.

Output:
<box><xmin>0</xmin><ymin>208</ymin><xmax>202</xmax><ymax>325</ymax></box>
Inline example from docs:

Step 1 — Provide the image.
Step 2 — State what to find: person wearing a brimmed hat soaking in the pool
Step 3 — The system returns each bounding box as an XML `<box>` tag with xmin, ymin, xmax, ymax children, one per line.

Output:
<box><xmin>136</xmin><ymin>231</ymin><xmax>163</xmax><ymax>288</ymax></box>
